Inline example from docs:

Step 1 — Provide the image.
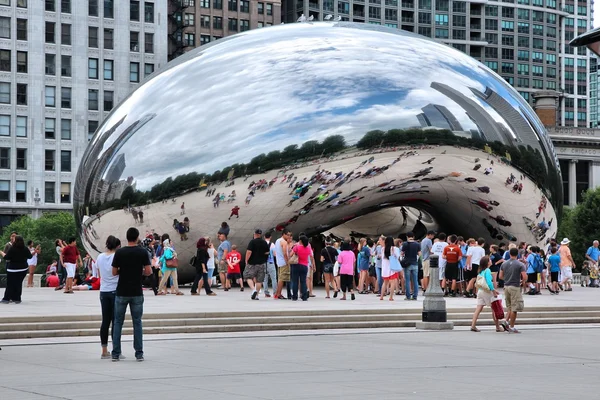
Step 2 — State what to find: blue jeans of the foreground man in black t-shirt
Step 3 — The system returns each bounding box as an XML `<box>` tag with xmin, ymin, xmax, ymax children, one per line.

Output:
<box><xmin>112</xmin><ymin>296</ymin><xmax>144</xmax><ymax>358</ymax></box>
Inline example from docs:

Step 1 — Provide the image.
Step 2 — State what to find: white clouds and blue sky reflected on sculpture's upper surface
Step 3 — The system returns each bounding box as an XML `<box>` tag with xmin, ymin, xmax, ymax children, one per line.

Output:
<box><xmin>86</xmin><ymin>24</ymin><xmax>552</xmax><ymax>190</ymax></box>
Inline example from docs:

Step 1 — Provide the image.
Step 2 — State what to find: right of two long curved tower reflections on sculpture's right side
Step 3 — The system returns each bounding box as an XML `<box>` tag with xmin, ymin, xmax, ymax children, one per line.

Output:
<box><xmin>470</xmin><ymin>87</ymin><xmax>540</xmax><ymax>150</ymax></box>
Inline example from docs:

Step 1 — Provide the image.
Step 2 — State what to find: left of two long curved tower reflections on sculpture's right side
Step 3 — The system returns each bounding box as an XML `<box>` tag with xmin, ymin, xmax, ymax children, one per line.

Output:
<box><xmin>431</xmin><ymin>82</ymin><xmax>514</xmax><ymax>145</ymax></box>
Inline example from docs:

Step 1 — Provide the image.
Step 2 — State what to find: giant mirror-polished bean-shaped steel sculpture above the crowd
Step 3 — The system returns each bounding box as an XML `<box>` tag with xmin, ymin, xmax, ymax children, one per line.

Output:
<box><xmin>74</xmin><ymin>22</ymin><xmax>562</xmax><ymax>282</ymax></box>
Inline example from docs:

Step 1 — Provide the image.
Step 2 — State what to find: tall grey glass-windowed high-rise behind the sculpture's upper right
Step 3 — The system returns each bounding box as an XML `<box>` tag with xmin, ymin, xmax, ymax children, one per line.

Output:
<box><xmin>282</xmin><ymin>0</ymin><xmax>593</xmax><ymax>127</ymax></box>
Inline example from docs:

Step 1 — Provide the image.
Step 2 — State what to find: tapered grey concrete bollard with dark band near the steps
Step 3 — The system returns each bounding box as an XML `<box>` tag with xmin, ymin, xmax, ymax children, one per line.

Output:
<box><xmin>416</xmin><ymin>254</ymin><xmax>454</xmax><ymax>330</ymax></box>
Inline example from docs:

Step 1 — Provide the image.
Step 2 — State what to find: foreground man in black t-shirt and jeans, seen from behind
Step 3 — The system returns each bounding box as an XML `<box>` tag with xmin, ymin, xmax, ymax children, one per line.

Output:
<box><xmin>112</xmin><ymin>228</ymin><xmax>152</xmax><ymax>361</ymax></box>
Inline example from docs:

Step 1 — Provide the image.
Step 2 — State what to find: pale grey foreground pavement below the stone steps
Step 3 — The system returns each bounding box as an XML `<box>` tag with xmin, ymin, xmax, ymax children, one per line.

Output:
<box><xmin>0</xmin><ymin>326</ymin><xmax>600</xmax><ymax>400</ymax></box>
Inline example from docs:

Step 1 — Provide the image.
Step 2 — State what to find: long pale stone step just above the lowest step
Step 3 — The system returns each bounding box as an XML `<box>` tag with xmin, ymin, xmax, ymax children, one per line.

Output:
<box><xmin>0</xmin><ymin>311</ymin><xmax>600</xmax><ymax>332</ymax></box>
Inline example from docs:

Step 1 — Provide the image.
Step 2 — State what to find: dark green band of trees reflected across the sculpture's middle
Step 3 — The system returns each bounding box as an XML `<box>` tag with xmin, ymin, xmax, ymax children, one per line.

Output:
<box><xmin>91</xmin><ymin>128</ymin><xmax>562</xmax><ymax>213</ymax></box>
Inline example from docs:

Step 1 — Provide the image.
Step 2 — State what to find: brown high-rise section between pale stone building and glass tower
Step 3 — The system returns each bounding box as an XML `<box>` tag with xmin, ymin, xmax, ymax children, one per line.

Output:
<box><xmin>169</xmin><ymin>0</ymin><xmax>281</xmax><ymax>59</ymax></box>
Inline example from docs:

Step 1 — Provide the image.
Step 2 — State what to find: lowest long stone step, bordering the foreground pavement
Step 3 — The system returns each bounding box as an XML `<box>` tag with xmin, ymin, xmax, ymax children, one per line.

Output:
<box><xmin>0</xmin><ymin>317</ymin><xmax>600</xmax><ymax>340</ymax></box>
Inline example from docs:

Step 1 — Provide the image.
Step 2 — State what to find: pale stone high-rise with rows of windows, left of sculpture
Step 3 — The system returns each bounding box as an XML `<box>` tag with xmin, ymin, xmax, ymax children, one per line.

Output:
<box><xmin>0</xmin><ymin>0</ymin><xmax>168</xmax><ymax>227</ymax></box>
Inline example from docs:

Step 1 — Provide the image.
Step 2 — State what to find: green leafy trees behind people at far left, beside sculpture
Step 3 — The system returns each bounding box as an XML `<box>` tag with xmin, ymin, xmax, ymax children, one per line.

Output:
<box><xmin>0</xmin><ymin>212</ymin><xmax>79</xmax><ymax>273</ymax></box>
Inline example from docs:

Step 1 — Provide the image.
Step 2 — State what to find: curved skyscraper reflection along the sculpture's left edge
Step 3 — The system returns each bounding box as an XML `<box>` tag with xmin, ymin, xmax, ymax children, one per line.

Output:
<box><xmin>86</xmin><ymin>113</ymin><xmax>156</xmax><ymax>204</ymax></box>
